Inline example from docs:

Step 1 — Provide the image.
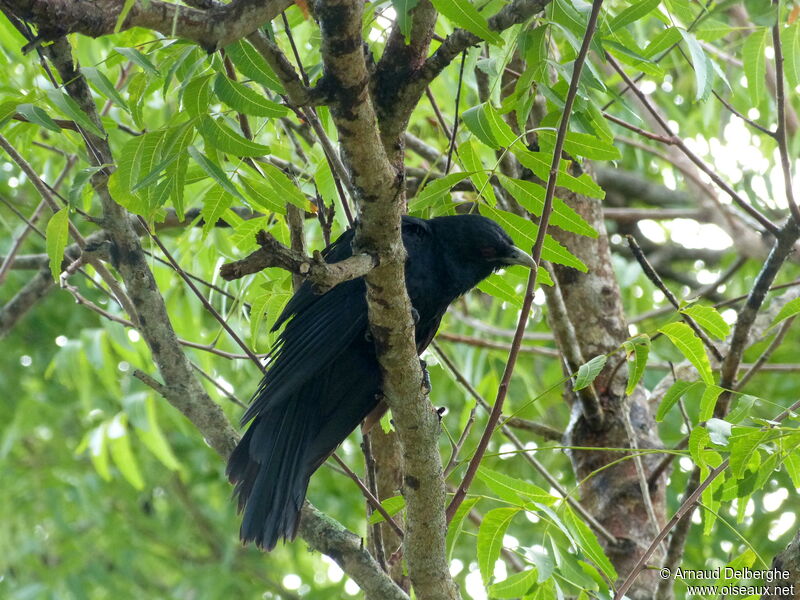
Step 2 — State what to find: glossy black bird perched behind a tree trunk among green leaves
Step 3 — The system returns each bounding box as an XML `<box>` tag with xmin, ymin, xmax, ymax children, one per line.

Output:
<box><xmin>227</xmin><ymin>215</ymin><xmax>533</xmax><ymax>550</ymax></box>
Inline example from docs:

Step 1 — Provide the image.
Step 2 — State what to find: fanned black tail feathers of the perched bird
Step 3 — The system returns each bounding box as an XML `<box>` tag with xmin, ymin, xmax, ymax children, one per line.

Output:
<box><xmin>226</xmin><ymin>402</ymin><xmax>313</xmax><ymax>551</ymax></box>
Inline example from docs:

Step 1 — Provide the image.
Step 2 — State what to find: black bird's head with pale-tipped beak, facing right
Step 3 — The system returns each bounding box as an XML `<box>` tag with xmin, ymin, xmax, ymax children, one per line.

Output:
<box><xmin>429</xmin><ymin>214</ymin><xmax>535</xmax><ymax>287</ymax></box>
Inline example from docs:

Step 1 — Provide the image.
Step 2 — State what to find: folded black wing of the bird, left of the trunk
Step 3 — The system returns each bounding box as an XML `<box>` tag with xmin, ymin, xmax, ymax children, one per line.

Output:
<box><xmin>242</xmin><ymin>279</ymin><xmax>367</xmax><ymax>423</ymax></box>
